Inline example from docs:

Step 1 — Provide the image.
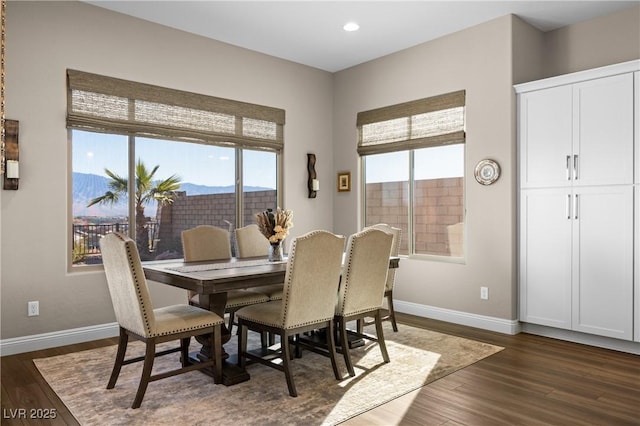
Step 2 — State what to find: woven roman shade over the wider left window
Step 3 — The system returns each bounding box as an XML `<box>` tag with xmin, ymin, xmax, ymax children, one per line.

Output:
<box><xmin>67</xmin><ymin>70</ymin><xmax>285</xmax><ymax>151</ymax></box>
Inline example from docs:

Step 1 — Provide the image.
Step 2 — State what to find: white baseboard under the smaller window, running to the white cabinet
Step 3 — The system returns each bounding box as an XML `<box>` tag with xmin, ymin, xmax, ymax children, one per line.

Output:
<box><xmin>393</xmin><ymin>300</ymin><xmax>520</xmax><ymax>334</ymax></box>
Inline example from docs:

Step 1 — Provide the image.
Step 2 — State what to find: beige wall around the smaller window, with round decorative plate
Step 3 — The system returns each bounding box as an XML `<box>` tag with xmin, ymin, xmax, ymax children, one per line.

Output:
<box><xmin>334</xmin><ymin>16</ymin><xmax>515</xmax><ymax>319</ymax></box>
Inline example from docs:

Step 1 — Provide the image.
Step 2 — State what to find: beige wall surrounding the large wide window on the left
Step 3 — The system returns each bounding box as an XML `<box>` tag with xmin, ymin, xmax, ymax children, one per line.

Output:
<box><xmin>0</xmin><ymin>1</ymin><xmax>334</xmax><ymax>339</ymax></box>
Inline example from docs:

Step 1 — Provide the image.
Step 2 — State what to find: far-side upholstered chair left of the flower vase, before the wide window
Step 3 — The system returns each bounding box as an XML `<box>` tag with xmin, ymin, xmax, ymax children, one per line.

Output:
<box><xmin>181</xmin><ymin>225</ymin><xmax>269</xmax><ymax>332</ymax></box>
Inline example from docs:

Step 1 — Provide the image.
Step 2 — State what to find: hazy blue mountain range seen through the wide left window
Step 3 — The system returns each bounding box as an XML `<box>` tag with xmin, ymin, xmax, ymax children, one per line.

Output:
<box><xmin>72</xmin><ymin>172</ymin><xmax>273</xmax><ymax>217</ymax></box>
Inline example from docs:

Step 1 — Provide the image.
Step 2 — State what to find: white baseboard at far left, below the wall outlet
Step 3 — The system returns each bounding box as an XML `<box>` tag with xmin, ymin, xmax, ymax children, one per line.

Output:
<box><xmin>0</xmin><ymin>322</ymin><xmax>120</xmax><ymax>356</ymax></box>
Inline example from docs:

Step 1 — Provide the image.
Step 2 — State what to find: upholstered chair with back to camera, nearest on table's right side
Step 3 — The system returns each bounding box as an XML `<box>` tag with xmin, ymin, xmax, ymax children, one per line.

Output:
<box><xmin>236</xmin><ymin>231</ymin><xmax>344</xmax><ymax>397</ymax></box>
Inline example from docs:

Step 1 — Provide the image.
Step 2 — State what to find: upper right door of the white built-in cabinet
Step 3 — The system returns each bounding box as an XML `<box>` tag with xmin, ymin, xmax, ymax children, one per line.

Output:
<box><xmin>571</xmin><ymin>73</ymin><xmax>634</xmax><ymax>186</ymax></box>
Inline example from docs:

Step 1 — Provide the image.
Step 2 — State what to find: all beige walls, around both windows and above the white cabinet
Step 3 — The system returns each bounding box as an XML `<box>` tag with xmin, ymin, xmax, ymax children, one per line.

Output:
<box><xmin>0</xmin><ymin>1</ymin><xmax>640</xmax><ymax>339</ymax></box>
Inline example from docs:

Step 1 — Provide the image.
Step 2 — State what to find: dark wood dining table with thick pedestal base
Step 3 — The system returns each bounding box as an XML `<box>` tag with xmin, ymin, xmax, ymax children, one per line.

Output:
<box><xmin>142</xmin><ymin>256</ymin><xmax>400</xmax><ymax>386</ymax></box>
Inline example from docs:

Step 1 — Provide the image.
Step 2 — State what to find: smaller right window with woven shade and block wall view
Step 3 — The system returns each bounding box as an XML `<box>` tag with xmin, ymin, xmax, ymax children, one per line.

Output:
<box><xmin>358</xmin><ymin>92</ymin><xmax>465</xmax><ymax>258</ymax></box>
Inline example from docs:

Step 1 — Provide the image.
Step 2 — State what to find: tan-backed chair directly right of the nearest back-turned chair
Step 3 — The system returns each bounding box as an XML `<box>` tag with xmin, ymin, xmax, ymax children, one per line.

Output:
<box><xmin>335</xmin><ymin>229</ymin><xmax>393</xmax><ymax>377</ymax></box>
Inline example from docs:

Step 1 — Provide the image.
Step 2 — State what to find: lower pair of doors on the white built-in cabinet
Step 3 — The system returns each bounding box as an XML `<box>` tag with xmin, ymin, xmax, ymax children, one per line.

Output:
<box><xmin>520</xmin><ymin>185</ymin><xmax>634</xmax><ymax>340</ymax></box>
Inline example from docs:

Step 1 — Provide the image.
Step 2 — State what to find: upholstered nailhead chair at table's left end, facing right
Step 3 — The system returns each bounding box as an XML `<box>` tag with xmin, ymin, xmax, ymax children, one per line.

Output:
<box><xmin>100</xmin><ymin>234</ymin><xmax>223</xmax><ymax>408</ymax></box>
